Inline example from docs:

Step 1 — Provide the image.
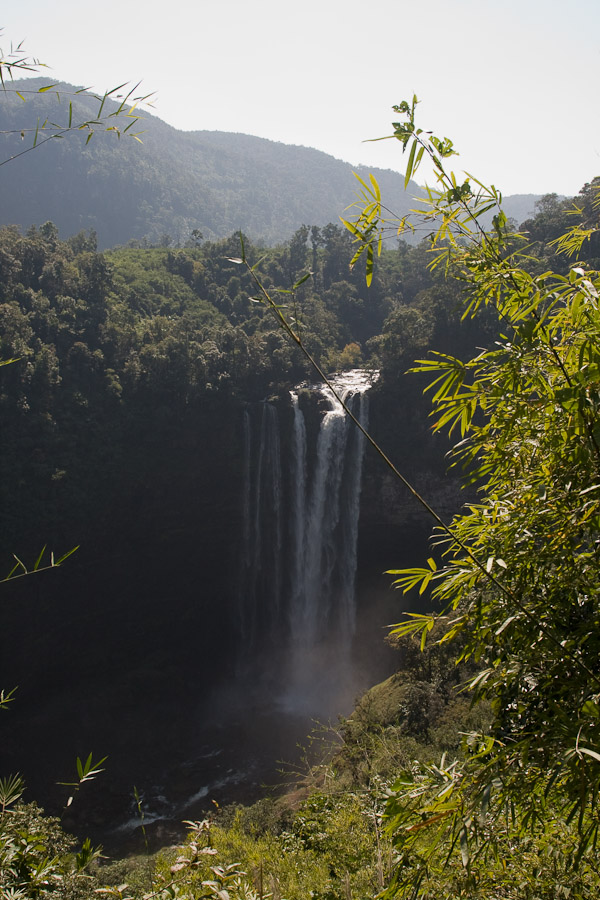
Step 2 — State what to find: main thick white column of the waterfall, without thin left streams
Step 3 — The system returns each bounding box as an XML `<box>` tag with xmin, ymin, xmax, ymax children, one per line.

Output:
<box><xmin>282</xmin><ymin>370</ymin><xmax>372</xmax><ymax>713</ymax></box>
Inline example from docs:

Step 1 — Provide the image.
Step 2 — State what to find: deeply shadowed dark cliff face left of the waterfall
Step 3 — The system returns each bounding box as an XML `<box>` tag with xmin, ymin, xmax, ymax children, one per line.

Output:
<box><xmin>0</xmin><ymin>394</ymin><xmax>246</xmax><ymax>809</ymax></box>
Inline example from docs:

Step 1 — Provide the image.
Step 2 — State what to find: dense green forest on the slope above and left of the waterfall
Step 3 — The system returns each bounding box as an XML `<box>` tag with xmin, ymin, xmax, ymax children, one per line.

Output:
<box><xmin>0</xmin><ymin>217</ymin><xmax>488</xmax><ymax>553</ymax></box>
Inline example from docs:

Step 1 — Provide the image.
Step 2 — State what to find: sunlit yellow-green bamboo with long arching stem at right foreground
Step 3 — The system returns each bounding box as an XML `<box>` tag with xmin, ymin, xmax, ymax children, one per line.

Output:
<box><xmin>235</xmin><ymin>97</ymin><xmax>600</xmax><ymax>884</ymax></box>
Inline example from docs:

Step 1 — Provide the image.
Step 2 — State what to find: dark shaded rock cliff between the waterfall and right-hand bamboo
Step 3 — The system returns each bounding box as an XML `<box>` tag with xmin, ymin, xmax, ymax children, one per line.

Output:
<box><xmin>357</xmin><ymin>378</ymin><xmax>467</xmax><ymax>683</ymax></box>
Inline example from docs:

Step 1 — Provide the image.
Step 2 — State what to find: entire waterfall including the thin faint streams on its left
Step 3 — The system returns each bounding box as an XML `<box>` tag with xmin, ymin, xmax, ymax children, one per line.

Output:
<box><xmin>240</xmin><ymin>370</ymin><xmax>373</xmax><ymax>714</ymax></box>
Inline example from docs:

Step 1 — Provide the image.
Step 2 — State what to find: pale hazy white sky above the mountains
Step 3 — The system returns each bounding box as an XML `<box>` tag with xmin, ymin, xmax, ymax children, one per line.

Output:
<box><xmin>0</xmin><ymin>0</ymin><xmax>600</xmax><ymax>194</ymax></box>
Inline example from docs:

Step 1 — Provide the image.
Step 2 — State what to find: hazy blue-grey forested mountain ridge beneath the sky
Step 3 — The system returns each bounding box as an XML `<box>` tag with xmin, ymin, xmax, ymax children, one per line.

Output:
<box><xmin>0</xmin><ymin>79</ymin><xmax>539</xmax><ymax>248</ymax></box>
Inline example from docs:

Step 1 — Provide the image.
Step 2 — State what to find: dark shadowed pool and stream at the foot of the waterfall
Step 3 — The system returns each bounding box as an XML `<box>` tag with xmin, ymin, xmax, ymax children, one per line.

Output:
<box><xmin>93</xmin><ymin>704</ymin><xmax>334</xmax><ymax>855</ymax></box>
